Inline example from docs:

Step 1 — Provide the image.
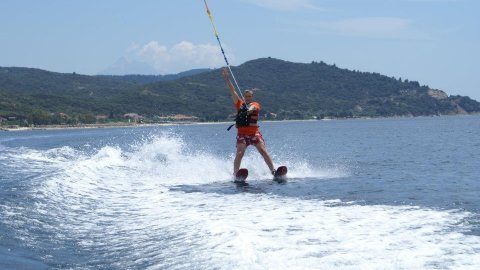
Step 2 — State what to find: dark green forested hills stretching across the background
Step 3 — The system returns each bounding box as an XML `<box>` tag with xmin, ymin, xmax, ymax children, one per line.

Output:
<box><xmin>0</xmin><ymin>58</ymin><xmax>480</xmax><ymax>123</ymax></box>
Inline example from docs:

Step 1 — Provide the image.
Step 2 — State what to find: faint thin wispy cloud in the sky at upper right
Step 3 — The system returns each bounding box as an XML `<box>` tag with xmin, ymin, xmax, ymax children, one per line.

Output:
<box><xmin>315</xmin><ymin>17</ymin><xmax>419</xmax><ymax>38</ymax></box>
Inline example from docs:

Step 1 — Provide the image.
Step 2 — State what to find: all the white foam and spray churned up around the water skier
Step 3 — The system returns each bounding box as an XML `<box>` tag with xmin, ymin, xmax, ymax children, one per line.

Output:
<box><xmin>3</xmin><ymin>135</ymin><xmax>480</xmax><ymax>269</ymax></box>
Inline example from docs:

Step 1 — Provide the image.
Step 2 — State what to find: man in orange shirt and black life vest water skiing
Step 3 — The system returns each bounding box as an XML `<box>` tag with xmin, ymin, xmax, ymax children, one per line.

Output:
<box><xmin>223</xmin><ymin>68</ymin><xmax>275</xmax><ymax>176</ymax></box>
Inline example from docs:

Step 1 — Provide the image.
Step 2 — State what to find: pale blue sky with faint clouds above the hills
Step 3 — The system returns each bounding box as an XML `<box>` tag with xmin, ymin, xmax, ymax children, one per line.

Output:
<box><xmin>0</xmin><ymin>0</ymin><xmax>480</xmax><ymax>100</ymax></box>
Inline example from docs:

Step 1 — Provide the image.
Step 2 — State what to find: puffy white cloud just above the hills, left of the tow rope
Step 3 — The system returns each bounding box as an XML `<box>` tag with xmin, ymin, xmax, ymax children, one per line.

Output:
<box><xmin>104</xmin><ymin>41</ymin><xmax>234</xmax><ymax>74</ymax></box>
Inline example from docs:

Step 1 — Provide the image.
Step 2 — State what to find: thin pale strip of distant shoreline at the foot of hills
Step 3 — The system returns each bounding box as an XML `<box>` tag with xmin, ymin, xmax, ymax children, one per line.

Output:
<box><xmin>0</xmin><ymin>114</ymin><xmax>480</xmax><ymax>131</ymax></box>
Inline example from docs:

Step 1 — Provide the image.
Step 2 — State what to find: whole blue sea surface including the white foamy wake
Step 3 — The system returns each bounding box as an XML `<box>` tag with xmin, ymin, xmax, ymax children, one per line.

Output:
<box><xmin>0</xmin><ymin>116</ymin><xmax>480</xmax><ymax>269</ymax></box>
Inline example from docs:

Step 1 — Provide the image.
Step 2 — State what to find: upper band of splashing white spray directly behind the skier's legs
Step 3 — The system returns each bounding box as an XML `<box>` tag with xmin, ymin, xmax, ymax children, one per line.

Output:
<box><xmin>7</xmin><ymin>134</ymin><xmax>348</xmax><ymax>185</ymax></box>
